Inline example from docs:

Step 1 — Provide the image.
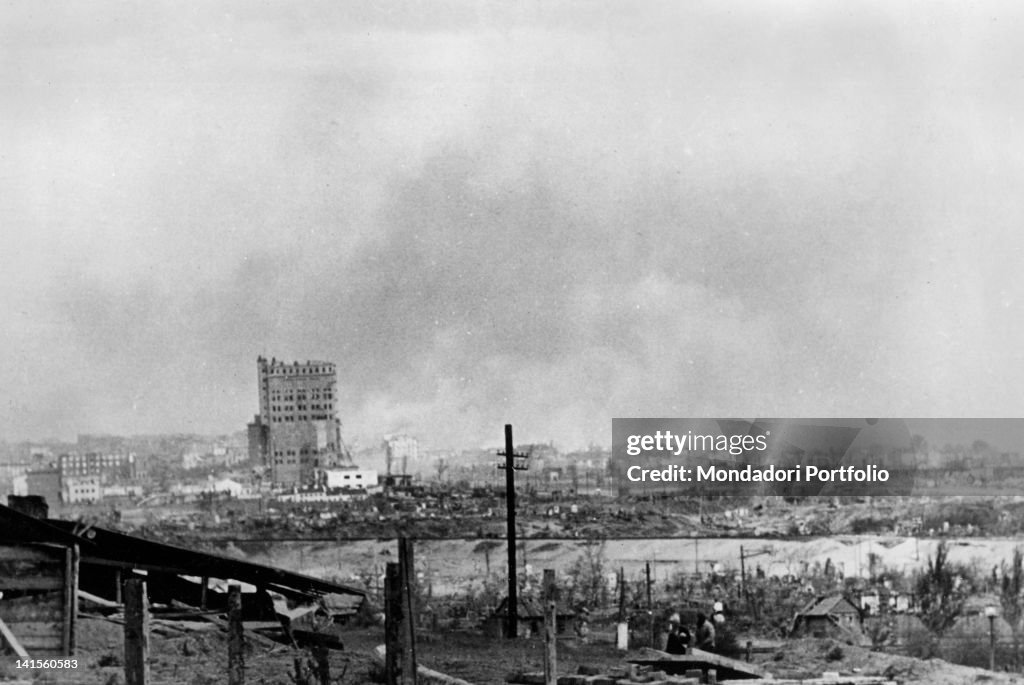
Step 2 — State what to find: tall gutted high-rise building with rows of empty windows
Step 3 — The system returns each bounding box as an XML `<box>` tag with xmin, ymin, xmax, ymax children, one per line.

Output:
<box><xmin>249</xmin><ymin>356</ymin><xmax>348</xmax><ymax>486</ymax></box>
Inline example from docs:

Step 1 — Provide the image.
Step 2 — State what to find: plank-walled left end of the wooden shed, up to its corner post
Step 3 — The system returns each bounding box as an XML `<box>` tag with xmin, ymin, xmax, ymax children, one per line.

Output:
<box><xmin>0</xmin><ymin>506</ymin><xmax>81</xmax><ymax>658</ymax></box>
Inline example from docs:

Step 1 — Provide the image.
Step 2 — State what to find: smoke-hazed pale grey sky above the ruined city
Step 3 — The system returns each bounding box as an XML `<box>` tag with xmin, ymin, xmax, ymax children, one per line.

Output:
<box><xmin>0</xmin><ymin>0</ymin><xmax>1024</xmax><ymax>448</ymax></box>
